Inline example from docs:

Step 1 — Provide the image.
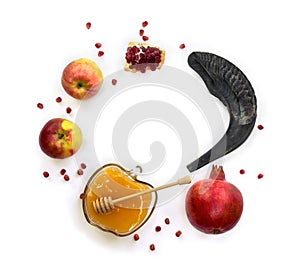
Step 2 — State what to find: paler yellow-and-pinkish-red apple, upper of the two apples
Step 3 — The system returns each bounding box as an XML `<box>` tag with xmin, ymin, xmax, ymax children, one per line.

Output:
<box><xmin>61</xmin><ymin>58</ymin><xmax>103</xmax><ymax>100</ymax></box>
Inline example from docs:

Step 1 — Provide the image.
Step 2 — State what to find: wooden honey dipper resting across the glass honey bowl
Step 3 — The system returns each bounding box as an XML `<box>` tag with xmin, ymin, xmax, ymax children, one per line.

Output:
<box><xmin>93</xmin><ymin>176</ymin><xmax>191</xmax><ymax>214</ymax></box>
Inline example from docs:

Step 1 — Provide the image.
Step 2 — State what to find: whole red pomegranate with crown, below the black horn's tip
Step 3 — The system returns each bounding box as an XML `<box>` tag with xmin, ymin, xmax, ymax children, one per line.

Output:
<box><xmin>185</xmin><ymin>166</ymin><xmax>243</xmax><ymax>234</ymax></box>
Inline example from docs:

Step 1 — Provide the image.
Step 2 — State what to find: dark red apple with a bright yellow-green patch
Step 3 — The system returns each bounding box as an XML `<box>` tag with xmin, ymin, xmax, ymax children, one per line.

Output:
<box><xmin>39</xmin><ymin>118</ymin><xmax>82</xmax><ymax>159</ymax></box>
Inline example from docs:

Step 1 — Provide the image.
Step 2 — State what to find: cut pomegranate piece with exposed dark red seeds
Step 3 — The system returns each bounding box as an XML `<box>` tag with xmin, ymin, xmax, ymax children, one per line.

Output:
<box><xmin>125</xmin><ymin>42</ymin><xmax>165</xmax><ymax>73</ymax></box>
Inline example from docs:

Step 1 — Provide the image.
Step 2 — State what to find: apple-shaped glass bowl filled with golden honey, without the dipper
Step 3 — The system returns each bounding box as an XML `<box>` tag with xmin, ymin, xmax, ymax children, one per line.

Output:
<box><xmin>83</xmin><ymin>164</ymin><xmax>157</xmax><ymax>236</ymax></box>
